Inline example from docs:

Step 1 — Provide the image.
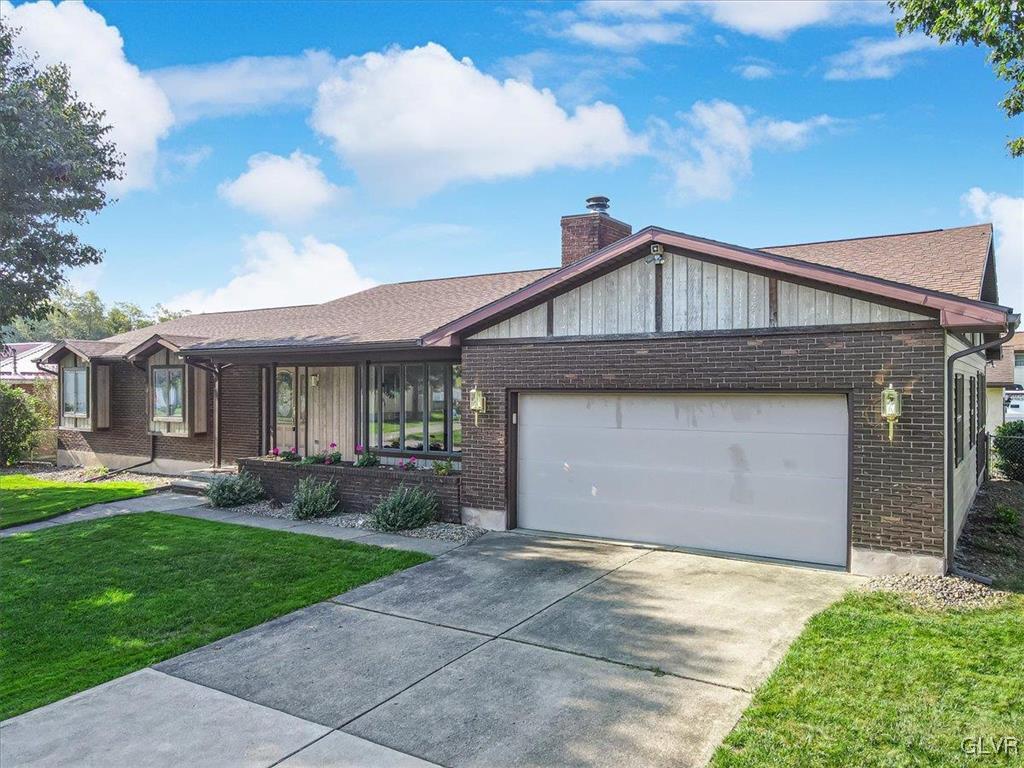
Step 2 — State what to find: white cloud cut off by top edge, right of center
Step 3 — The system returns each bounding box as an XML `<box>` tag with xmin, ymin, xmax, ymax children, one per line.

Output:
<box><xmin>563</xmin><ymin>0</ymin><xmax>890</xmax><ymax>44</ymax></box>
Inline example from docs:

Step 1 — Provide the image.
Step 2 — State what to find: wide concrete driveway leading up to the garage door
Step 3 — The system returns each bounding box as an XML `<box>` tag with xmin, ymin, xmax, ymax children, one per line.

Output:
<box><xmin>0</xmin><ymin>534</ymin><xmax>857</xmax><ymax>768</ymax></box>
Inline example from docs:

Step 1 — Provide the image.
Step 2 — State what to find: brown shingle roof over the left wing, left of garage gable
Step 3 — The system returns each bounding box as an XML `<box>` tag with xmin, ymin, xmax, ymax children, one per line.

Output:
<box><xmin>99</xmin><ymin>269</ymin><xmax>553</xmax><ymax>354</ymax></box>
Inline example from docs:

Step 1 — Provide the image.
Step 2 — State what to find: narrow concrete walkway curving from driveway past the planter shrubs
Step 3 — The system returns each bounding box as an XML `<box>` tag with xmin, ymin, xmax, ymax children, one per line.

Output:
<box><xmin>0</xmin><ymin>492</ymin><xmax>463</xmax><ymax>556</ymax></box>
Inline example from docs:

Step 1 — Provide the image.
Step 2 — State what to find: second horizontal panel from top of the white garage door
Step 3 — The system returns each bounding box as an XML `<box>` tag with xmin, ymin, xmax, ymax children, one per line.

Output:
<box><xmin>519</xmin><ymin>430</ymin><xmax>849</xmax><ymax>477</ymax></box>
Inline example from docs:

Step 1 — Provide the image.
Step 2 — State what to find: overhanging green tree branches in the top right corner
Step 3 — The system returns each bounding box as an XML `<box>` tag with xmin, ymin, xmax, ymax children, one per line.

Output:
<box><xmin>889</xmin><ymin>0</ymin><xmax>1024</xmax><ymax>158</ymax></box>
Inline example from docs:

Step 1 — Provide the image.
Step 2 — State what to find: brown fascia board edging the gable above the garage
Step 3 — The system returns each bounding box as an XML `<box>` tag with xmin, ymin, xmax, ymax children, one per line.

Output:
<box><xmin>423</xmin><ymin>226</ymin><xmax>1010</xmax><ymax>346</ymax></box>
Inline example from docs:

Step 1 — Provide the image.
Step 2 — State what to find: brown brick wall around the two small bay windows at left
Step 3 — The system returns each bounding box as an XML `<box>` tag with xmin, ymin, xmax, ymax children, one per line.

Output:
<box><xmin>57</xmin><ymin>362</ymin><xmax>260</xmax><ymax>465</ymax></box>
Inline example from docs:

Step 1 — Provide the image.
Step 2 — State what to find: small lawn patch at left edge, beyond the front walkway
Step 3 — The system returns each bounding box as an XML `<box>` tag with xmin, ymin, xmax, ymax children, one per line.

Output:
<box><xmin>0</xmin><ymin>475</ymin><xmax>148</xmax><ymax>528</ymax></box>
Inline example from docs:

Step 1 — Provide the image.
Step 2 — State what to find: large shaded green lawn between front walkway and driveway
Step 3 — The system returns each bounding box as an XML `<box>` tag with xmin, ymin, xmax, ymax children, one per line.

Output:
<box><xmin>0</xmin><ymin>512</ymin><xmax>430</xmax><ymax>720</ymax></box>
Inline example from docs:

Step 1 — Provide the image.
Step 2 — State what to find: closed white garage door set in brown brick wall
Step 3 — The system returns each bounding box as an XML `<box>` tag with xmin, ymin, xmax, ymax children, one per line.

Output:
<box><xmin>517</xmin><ymin>393</ymin><xmax>849</xmax><ymax>565</ymax></box>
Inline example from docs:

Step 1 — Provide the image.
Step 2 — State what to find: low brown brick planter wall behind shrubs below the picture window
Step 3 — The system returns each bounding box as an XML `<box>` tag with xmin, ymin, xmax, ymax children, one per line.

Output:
<box><xmin>239</xmin><ymin>459</ymin><xmax>461</xmax><ymax>522</ymax></box>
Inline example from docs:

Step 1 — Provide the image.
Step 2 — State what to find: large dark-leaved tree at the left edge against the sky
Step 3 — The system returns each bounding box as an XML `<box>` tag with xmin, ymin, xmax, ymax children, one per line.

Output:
<box><xmin>0</xmin><ymin>19</ymin><xmax>124</xmax><ymax>341</ymax></box>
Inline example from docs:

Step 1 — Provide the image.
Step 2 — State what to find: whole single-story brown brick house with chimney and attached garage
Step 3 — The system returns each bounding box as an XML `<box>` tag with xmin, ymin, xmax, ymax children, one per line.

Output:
<box><xmin>41</xmin><ymin>199</ymin><xmax>1019</xmax><ymax>573</ymax></box>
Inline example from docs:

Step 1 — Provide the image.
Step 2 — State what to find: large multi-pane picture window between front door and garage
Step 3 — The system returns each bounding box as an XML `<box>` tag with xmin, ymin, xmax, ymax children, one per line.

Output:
<box><xmin>366</xmin><ymin>362</ymin><xmax>462</xmax><ymax>454</ymax></box>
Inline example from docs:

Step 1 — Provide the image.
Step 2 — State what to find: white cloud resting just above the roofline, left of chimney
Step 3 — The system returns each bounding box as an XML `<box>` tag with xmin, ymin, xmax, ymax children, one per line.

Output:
<box><xmin>167</xmin><ymin>231</ymin><xmax>377</xmax><ymax>312</ymax></box>
